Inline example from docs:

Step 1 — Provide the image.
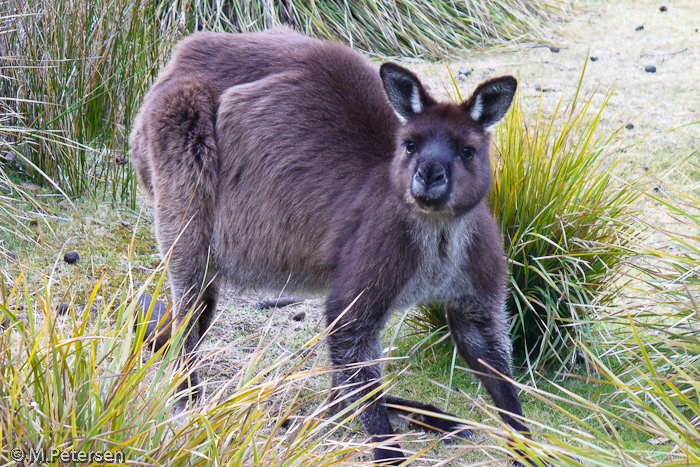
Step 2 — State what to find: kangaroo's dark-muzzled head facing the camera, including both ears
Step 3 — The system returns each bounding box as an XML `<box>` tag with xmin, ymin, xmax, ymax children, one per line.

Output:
<box><xmin>380</xmin><ymin>63</ymin><xmax>517</xmax><ymax>216</ymax></box>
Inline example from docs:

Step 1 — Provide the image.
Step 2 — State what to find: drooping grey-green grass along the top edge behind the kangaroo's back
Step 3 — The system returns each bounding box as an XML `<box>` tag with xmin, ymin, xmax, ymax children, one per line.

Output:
<box><xmin>190</xmin><ymin>0</ymin><xmax>571</xmax><ymax>59</ymax></box>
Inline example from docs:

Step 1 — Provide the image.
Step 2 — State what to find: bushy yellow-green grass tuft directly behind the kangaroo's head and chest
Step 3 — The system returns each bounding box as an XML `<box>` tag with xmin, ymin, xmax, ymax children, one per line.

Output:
<box><xmin>413</xmin><ymin>69</ymin><xmax>644</xmax><ymax>370</ymax></box>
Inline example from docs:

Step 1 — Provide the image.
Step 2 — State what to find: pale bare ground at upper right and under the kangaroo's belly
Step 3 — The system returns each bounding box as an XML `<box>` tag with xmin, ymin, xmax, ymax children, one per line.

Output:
<box><xmin>187</xmin><ymin>0</ymin><xmax>700</xmax><ymax>462</ymax></box>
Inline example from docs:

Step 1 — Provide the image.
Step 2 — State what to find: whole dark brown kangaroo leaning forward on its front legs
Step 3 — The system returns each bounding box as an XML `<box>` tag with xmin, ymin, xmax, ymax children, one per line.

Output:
<box><xmin>129</xmin><ymin>28</ymin><xmax>533</xmax><ymax>464</ymax></box>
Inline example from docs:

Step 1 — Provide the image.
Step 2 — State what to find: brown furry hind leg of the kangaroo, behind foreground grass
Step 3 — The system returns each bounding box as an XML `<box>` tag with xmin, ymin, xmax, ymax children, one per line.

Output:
<box><xmin>143</xmin><ymin>77</ymin><xmax>219</xmax><ymax>402</ymax></box>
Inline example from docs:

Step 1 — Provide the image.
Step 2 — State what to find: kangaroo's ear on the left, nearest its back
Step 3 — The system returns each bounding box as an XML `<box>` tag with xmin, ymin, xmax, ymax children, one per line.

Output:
<box><xmin>379</xmin><ymin>63</ymin><xmax>432</xmax><ymax>123</ymax></box>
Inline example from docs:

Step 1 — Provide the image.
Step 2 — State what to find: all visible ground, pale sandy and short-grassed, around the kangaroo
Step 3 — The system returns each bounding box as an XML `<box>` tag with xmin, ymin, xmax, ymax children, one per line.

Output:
<box><xmin>3</xmin><ymin>0</ymin><xmax>700</xmax><ymax>465</ymax></box>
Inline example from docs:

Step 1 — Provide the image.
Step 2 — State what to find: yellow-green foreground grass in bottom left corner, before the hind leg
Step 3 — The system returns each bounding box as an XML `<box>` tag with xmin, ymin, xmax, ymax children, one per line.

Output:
<box><xmin>0</xmin><ymin>275</ymin><xmax>366</xmax><ymax>467</ymax></box>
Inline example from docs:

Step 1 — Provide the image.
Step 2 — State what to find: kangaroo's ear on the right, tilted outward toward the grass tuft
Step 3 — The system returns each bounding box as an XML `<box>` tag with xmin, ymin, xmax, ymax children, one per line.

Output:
<box><xmin>462</xmin><ymin>76</ymin><xmax>518</xmax><ymax>132</ymax></box>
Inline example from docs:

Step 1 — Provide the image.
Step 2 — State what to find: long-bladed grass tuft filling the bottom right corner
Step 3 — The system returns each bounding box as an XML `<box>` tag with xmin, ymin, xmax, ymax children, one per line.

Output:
<box><xmin>498</xmin><ymin>186</ymin><xmax>700</xmax><ymax>467</ymax></box>
